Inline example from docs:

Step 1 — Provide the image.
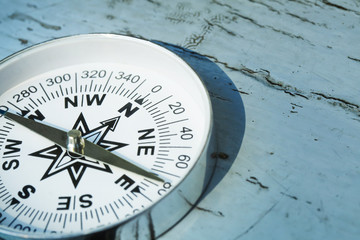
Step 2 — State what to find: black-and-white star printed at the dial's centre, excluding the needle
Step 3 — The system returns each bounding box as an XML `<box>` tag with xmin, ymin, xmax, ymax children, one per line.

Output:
<box><xmin>30</xmin><ymin>113</ymin><xmax>128</xmax><ymax>188</ymax></box>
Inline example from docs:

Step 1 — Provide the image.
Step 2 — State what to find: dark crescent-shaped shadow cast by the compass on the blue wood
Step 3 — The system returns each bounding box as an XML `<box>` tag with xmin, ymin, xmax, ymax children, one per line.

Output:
<box><xmin>152</xmin><ymin>41</ymin><xmax>245</xmax><ymax>200</ymax></box>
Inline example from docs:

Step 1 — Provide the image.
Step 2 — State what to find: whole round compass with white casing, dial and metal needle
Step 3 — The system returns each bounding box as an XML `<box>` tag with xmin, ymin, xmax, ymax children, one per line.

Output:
<box><xmin>0</xmin><ymin>34</ymin><xmax>214</xmax><ymax>239</ymax></box>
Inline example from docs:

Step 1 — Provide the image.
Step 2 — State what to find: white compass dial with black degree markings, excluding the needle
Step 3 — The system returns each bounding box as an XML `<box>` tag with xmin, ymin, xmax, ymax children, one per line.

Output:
<box><xmin>0</xmin><ymin>34</ymin><xmax>210</xmax><ymax>237</ymax></box>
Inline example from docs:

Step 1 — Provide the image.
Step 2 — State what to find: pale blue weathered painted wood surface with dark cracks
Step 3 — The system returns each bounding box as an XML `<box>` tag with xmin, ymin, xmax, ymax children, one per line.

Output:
<box><xmin>0</xmin><ymin>0</ymin><xmax>360</xmax><ymax>240</ymax></box>
